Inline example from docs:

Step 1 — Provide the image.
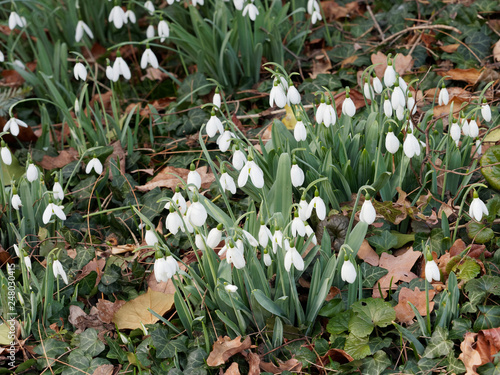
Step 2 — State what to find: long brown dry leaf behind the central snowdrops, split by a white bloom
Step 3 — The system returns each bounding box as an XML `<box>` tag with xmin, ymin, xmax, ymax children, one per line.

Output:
<box><xmin>137</xmin><ymin>166</ymin><xmax>215</xmax><ymax>191</ymax></box>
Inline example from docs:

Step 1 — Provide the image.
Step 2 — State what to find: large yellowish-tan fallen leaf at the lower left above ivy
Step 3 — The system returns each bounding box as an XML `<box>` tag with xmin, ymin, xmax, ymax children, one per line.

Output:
<box><xmin>113</xmin><ymin>289</ymin><xmax>174</xmax><ymax>329</ymax></box>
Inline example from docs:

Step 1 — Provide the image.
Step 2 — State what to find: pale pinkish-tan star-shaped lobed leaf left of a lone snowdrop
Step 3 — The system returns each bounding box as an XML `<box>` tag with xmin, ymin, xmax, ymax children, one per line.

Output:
<box><xmin>373</xmin><ymin>248</ymin><xmax>422</xmax><ymax>298</ymax></box>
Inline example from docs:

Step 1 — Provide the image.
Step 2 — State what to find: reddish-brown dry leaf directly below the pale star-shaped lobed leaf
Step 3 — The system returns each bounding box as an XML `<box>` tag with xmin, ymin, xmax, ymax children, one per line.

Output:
<box><xmin>394</xmin><ymin>288</ymin><xmax>436</xmax><ymax>325</ymax></box>
